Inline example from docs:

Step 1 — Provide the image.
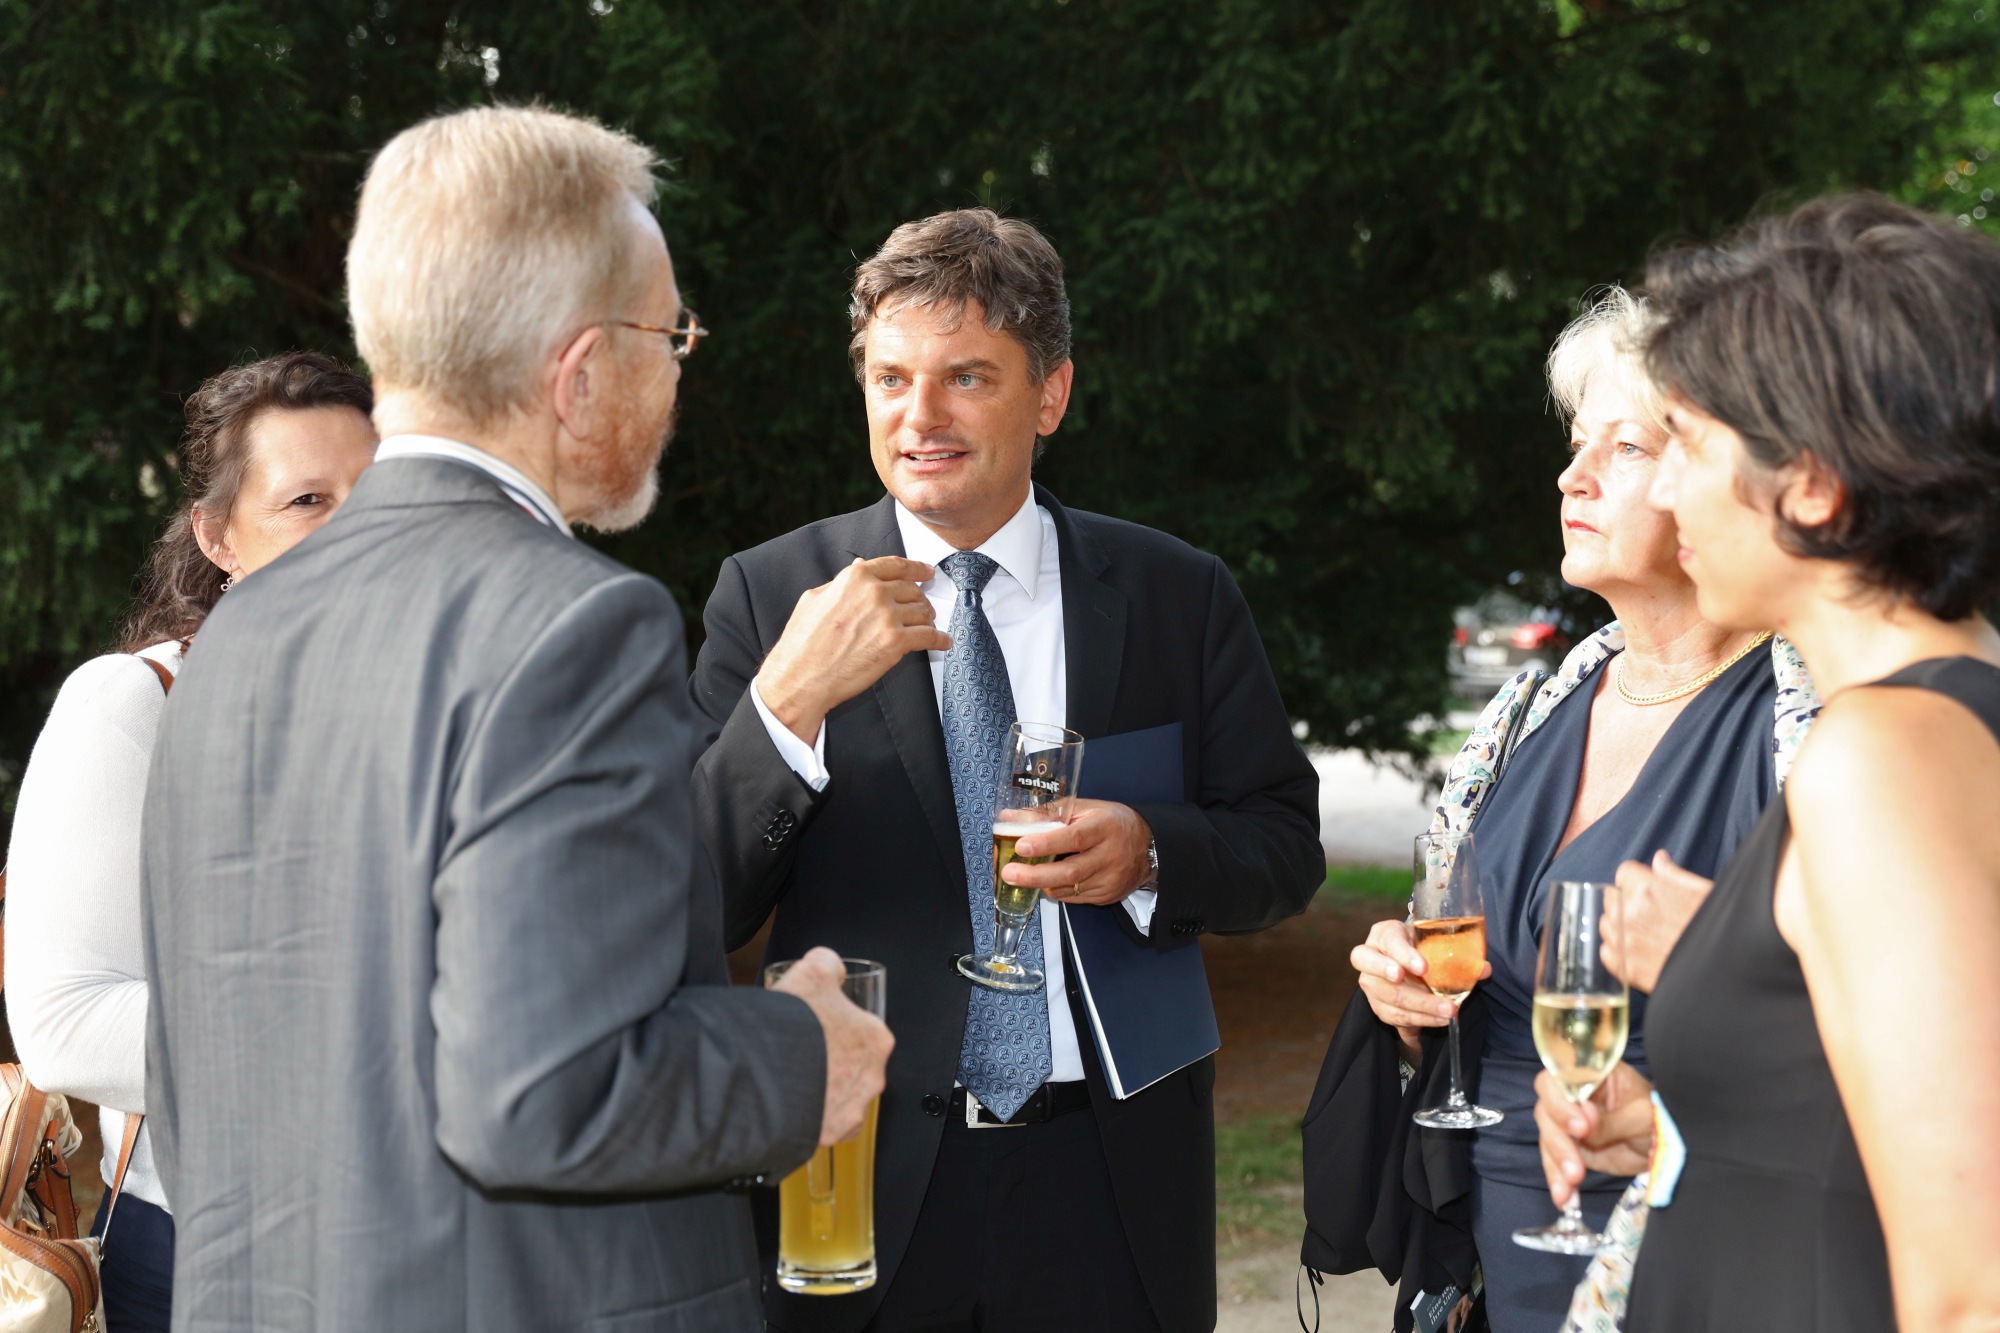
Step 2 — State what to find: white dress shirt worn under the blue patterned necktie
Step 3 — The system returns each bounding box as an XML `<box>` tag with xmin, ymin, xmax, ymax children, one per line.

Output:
<box><xmin>750</xmin><ymin>492</ymin><xmax>1158</xmax><ymax>1083</ymax></box>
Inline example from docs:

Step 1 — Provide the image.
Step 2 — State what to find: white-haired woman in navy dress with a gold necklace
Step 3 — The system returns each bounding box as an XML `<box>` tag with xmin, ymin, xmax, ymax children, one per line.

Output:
<box><xmin>1352</xmin><ymin>288</ymin><xmax>1798</xmax><ymax>1333</ymax></box>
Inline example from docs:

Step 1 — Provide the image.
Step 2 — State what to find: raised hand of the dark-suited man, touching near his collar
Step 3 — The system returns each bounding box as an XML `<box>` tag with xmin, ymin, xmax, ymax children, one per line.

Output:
<box><xmin>752</xmin><ymin>556</ymin><xmax>952</xmax><ymax>745</ymax></box>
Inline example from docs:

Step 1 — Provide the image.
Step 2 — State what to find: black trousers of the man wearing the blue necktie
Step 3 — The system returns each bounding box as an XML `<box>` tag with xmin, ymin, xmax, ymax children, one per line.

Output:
<box><xmin>868</xmin><ymin>1111</ymin><xmax>1160</xmax><ymax>1333</ymax></box>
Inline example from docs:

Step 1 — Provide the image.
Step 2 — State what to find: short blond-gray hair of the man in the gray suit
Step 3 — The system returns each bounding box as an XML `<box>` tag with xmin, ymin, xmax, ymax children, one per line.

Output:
<box><xmin>348</xmin><ymin>106</ymin><xmax>658</xmax><ymax>426</ymax></box>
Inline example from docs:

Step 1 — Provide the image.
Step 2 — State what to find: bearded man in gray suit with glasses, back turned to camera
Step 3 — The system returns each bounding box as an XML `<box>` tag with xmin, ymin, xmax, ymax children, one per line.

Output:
<box><xmin>141</xmin><ymin>108</ymin><xmax>890</xmax><ymax>1333</ymax></box>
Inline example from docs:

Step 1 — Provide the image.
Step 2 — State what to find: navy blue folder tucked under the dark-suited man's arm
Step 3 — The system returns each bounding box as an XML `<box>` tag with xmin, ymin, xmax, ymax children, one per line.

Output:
<box><xmin>1062</xmin><ymin>723</ymin><xmax>1222</xmax><ymax>1101</ymax></box>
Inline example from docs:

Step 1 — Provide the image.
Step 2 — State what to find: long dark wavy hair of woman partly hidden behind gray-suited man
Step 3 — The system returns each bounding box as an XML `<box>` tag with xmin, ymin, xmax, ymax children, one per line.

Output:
<box><xmin>120</xmin><ymin>352</ymin><xmax>374</xmax><ymax>652</ymax></box>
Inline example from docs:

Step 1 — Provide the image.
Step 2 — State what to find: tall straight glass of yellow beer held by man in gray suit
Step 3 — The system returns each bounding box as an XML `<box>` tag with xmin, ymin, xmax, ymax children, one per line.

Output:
<box><xmin>764</xmin><ymin>959</ymin><xmax>888</xmax><ymax>1295</ymax></box>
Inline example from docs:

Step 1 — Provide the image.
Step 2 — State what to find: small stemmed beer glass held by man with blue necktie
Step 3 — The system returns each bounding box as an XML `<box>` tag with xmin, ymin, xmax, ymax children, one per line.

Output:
<box><xmin>958</xmin><ymin>723</ymin><xmax>1084</xmax><ymax>991</ymax></box>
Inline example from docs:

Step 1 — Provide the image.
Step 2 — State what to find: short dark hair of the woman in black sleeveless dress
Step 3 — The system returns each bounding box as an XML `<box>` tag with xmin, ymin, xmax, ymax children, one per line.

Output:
<box><xmin>1646</xmin><ymin>194</ymin><xmax>2000</xmax><ymax>620</ymax></box>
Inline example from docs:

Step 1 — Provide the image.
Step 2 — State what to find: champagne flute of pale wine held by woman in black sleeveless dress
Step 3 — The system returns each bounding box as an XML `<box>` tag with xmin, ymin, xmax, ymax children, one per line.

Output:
<box><xmin>1514</xmin><ymin>881</ymin><xmax>1632</xmax><ymax>1255</ymax></box>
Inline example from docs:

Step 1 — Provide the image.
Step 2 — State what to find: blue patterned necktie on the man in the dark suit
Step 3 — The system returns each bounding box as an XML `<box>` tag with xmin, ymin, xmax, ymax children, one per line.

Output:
<box><xmin>938</xmin><ymin>550</ymin><xmax>1054</xmax><ymax>1119</ymax></box>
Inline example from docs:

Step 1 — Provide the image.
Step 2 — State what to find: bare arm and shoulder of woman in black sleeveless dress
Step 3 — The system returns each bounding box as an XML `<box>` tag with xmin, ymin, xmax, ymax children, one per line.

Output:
<box><xmin>1776</xmin><ymin>689</ymin><xmax>2000</xmax><ymax>1331</ymax></box>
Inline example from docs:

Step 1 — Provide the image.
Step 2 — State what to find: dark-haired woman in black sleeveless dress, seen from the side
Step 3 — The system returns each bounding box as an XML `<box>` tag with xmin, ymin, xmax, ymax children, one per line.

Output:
<box><xmin>1542</xmin><ymin>196</ymin><xmax>2000</xmax><ymax>1333</ymax></box>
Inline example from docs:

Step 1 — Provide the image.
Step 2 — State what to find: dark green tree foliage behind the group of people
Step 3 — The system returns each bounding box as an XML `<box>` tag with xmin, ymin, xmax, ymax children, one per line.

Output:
<box><xmin>0</xmin><ymin>0</ymin><xmax>2000</xmax><ymax>840</ymax></box>
